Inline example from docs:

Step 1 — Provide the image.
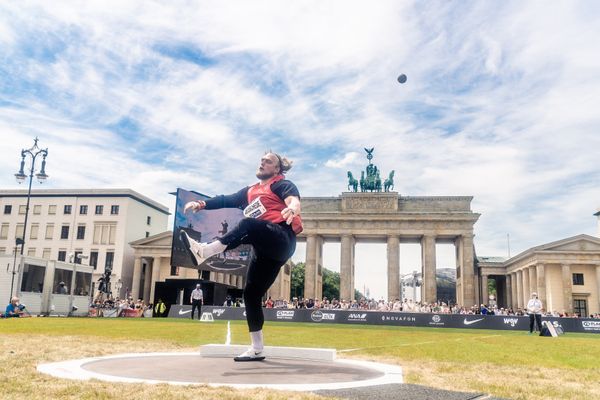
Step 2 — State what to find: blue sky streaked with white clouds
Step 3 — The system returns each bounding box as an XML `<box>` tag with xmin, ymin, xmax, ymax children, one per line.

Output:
<box><xmin>0</xmin><ymin>1</ymin><xmax>600</xmax><ymax>300</ymax></box>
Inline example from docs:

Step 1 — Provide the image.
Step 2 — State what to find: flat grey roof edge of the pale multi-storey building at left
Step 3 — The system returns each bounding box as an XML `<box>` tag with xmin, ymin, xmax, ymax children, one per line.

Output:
<box><xmin>0</xmin><ymin>189</ymin><xmax>169</xmax><ymax>215</ymax></box>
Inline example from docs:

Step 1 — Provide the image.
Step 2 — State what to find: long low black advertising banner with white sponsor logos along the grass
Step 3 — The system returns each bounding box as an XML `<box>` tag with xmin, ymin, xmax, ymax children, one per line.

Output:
<box><xmin>169</xmin><ymin>305</ymin><xmax>600</xmax><ymax>333</ymax></box>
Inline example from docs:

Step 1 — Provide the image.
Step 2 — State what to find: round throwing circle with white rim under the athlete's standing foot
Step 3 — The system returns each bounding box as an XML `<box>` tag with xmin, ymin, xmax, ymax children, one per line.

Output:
<box><xmin>37</xmin><ymin>353</ymin><xmax>402</xmax><ymax>390</ymax></box>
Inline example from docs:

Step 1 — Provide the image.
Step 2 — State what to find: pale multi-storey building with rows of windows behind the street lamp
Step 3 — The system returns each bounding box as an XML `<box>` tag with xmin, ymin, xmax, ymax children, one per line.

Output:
<box><xmin>0</xmin><ymin>189</ymin><xmax>169</xmax><ymax>296</ymax></box>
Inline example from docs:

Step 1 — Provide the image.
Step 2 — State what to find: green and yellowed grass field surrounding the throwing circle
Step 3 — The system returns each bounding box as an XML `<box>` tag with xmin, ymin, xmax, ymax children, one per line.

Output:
<box><xmin>0</xmin><ymin>318</ymin><xmax>600</xmax><ymax>400</ymax></box>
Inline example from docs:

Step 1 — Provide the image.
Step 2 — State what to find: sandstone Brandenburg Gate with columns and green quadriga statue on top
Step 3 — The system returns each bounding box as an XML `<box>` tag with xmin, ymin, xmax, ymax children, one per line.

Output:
<box><xmin>299</xmin><ymin>149</ymin><xmax>480</xmax><ymax>307</ymax></box>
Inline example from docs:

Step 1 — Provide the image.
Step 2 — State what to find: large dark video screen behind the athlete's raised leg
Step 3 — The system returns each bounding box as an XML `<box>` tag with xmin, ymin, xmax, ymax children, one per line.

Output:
<box><xmin>171</xmin><ymin>189</ymin><xmax>252</xmax><ymax>275</ymax></box>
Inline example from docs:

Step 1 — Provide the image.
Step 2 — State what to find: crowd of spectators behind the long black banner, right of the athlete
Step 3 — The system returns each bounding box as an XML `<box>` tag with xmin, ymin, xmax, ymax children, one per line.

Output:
<box><xmin>264</xmin><ymin>297</ymin><xmax>600</xmax><ymax>318</ymax></box>
